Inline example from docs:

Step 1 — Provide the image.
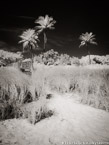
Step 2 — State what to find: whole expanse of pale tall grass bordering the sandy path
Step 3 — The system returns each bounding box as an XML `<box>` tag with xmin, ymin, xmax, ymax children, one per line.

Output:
<box><xmin>0</xmin><ymin>66</ymin><xmax>109</xmax><ymax>123</ymax></box>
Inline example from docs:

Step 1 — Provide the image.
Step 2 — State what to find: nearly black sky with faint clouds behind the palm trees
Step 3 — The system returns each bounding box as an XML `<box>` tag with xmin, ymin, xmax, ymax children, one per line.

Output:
<box><xmin>0</xmin><ymin>0</ymin><xmax>109</xmax><ymax>55</ymax></box>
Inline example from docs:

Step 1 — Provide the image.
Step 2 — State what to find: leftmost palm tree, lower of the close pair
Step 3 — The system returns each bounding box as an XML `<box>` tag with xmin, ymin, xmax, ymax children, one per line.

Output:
<box><xmin>19</xmin><ymin>29</ymin><xmax>39</xmax><ymax>69</ymax></box>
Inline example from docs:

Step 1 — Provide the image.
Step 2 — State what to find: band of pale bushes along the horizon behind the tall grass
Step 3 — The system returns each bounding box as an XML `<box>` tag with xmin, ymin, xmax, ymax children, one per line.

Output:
<box><xmin>0</xmin><ymin>49</ymin><xmax>109</xmax><ymax>66</ymax></box>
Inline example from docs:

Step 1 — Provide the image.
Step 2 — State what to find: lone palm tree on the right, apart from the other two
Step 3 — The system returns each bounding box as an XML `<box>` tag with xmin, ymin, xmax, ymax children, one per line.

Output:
<box><xmin>79</xmin><ymin>32</ymin><xmax>97</xmax><ymax>64</ymax></box>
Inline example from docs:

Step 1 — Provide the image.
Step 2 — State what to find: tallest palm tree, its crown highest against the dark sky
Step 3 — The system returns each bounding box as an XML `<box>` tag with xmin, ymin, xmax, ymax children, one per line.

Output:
<box><xmin>35</xmin><ymin>15</ymin><xmax>56</xmax><ymax>51</ymax></box>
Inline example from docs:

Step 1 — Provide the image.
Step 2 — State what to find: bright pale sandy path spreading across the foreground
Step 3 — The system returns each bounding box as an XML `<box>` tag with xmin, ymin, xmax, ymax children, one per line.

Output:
<box><xmin>0</xmin><ymin>94</ymin><xmax>109</xmax><ymax>145</ymax></box>
